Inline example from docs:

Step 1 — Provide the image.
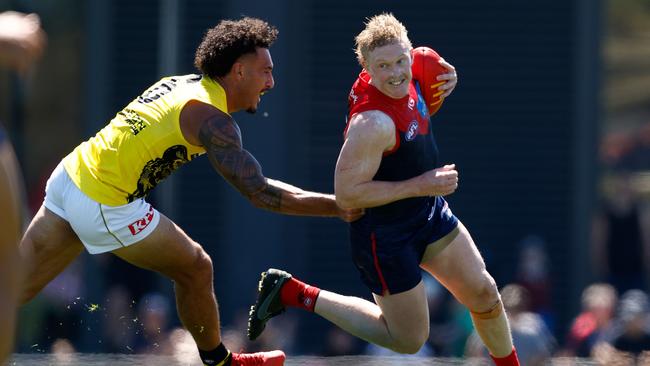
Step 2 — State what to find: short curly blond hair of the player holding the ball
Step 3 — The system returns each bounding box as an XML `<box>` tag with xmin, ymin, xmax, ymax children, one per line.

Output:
<box><xmin>354</xmin><ymin>13</ymin><xmax>412</xmax><ymax>67</ymax></box>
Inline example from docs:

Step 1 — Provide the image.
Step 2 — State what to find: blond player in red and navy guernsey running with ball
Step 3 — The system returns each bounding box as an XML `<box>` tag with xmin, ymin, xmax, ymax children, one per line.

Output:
<box><xmin>248</xmin><ymin>14</ymin><xmax>519</xmax><ymax>365</ymax></box>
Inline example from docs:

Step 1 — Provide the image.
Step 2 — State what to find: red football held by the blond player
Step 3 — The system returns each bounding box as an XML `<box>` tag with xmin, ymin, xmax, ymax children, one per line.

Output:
<box><xmin>411</xmin><ymin>47</ymin><xmax>449</xmax><ymax>116</ymax></box>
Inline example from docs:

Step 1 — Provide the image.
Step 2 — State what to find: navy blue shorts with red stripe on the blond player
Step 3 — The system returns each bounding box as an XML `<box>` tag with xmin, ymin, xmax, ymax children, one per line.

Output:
<box><xmin>350</xmin><ymin>197</ymin><xmax>458</xmax><ymax>295</ymax></box>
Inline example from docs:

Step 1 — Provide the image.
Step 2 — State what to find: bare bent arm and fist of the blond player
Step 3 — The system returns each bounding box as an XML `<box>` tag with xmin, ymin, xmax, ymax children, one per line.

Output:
<box><xmin>334</xmin><ymin>111</ymin><xmax>458</xmax><ymax>208</ymax></box>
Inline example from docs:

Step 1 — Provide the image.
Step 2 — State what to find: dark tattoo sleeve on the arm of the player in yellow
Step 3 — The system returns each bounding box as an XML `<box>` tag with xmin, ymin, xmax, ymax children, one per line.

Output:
<box><xmin>199</xmin><ymin>114</ymin><xmax>282</xmax><ymax>210</ymax></box>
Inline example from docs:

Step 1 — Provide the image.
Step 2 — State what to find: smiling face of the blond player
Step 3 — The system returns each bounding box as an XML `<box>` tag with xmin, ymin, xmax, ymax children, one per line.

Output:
<box><xmin>366</xmin><ymin>42</ymin><xmax>411</xmax><ymax>99</ymax></box>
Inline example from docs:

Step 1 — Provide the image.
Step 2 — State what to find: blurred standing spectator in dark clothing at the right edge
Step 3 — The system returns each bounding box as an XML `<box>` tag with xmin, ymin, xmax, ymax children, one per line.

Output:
<box><xmin>592</xmin><ymin>173</ymin><xmax>650</xmax><ymax>293</ymax></box>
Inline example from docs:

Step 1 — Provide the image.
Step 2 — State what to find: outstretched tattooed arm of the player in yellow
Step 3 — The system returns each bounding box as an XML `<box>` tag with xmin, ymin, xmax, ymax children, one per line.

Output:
<box><xmin>199</xmin><ymin>108</ymin><xmax>346</xmax><ymax>220</ymax></box>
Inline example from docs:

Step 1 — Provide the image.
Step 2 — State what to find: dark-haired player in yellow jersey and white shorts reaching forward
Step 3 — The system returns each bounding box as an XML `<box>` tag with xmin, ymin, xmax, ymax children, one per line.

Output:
<box><xmin>20</xmin><ymin>18</ymin><xmax>361</xmax><ymax>365</ymax></box>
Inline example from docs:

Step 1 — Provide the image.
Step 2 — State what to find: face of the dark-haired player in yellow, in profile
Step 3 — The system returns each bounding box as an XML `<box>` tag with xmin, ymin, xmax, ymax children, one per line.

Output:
<box><xmin>241</xmin><ymin>48</ymin><xmax>275</xmax><ymax>113</ymax></box>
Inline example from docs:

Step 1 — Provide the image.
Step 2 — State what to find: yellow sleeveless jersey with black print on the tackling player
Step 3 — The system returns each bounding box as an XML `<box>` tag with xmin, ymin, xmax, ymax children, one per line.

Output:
<box><xmin>63</xmin><ymin>75</ymin><xmax>228</xmax><ymax>206</ymax></box>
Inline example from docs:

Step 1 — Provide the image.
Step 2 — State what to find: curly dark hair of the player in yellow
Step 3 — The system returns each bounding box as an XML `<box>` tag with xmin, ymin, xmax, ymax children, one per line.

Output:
<box><xmin>194</xmin><ymin>17</ymin><xmax>278</xmax><ymax>78</ymax></box>
